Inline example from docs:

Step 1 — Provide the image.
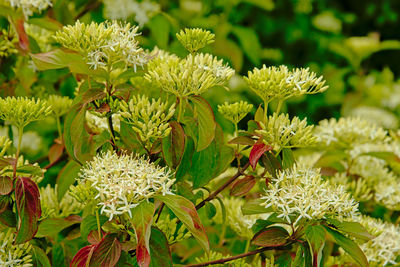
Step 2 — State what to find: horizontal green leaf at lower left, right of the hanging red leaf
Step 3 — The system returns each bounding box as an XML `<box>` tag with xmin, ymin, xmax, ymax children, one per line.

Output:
<box><xmin>36</xmin><ymin>215</ymin><xmax>81</xmax><ymax>239</ymax></box>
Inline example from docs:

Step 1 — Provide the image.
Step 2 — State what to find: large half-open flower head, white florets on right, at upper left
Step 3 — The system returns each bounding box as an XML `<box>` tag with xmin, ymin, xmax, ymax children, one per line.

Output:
<box><xmin>54</xmin><ymin>21</ymin><xmax>147</xmax><ymax>70</ymax></box>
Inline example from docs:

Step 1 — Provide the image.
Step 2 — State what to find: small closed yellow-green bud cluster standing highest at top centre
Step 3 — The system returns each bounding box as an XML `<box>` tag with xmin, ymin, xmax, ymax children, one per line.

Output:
<box><xmin>176</xmin><ymin>28</ymin><xmax>215</xmax><ymax>54</ymax></box>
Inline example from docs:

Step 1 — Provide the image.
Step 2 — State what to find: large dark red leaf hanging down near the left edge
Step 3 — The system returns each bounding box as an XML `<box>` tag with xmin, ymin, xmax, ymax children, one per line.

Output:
<box><xmin>15</xmin><ymin>177</ymin><xmax>42</xmax><ymax>244</ymax></box>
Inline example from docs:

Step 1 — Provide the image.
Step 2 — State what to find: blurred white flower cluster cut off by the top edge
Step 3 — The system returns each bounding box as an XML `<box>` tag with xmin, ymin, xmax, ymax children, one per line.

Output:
<box><xmin>103</xmin><ymin>0</ymin><xmax>160</xmax><ymax>27</ymax></box>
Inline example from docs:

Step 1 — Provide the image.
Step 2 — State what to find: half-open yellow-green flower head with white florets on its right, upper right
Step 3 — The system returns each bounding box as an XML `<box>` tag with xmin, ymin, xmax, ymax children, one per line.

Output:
<box><xmin>244</xmin><ymin>65</ymin><xmax>328</xmax><ymax>103</ymax></box>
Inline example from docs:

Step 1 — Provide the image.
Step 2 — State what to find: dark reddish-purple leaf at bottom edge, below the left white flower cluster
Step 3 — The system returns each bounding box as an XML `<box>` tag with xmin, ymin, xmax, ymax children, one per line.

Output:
<box><xmin>89</xmin><ymin>235</ymin><xmax>122</xmax><ymax>267</ymax></box>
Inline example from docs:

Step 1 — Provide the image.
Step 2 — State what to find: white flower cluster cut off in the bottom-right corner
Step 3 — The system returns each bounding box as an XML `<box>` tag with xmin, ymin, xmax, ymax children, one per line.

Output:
<box><xmin>358</xmin><ymin>216</ymin><xmax>400</xmax><ymax>267</ymax></box>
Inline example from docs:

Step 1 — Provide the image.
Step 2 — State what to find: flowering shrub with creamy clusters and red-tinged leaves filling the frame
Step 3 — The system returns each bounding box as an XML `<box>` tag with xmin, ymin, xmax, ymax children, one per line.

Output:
<box><xmin>0</xmin><ymin>0</ymin><xmax>400</xmax><ymax>267</ymax></box>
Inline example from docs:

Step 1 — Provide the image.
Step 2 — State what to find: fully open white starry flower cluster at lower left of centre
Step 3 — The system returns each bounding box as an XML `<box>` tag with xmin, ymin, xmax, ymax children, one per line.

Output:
<box><xmin>78</xmin><ymin>151</ymin><xmax>174</xmax><ymax>220</ymax></box>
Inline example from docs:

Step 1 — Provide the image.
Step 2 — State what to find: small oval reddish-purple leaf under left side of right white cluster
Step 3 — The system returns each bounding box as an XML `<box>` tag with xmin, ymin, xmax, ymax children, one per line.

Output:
<box><xmin>251</xmin><ymin>226</ymin><xmax>289</xmax><ymax>247</ymax></box>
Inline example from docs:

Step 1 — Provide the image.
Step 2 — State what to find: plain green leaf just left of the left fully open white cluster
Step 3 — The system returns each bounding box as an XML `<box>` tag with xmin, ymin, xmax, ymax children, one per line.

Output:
<box><xmin>56</xmin><ymin>160</ymin><xmax>81</xmax><ymax>201</ymax></box>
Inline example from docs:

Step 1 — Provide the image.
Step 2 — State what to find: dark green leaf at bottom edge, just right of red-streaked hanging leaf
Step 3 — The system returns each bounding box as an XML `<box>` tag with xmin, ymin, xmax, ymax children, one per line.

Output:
<box><xmin>150</xmin><ymin>227</ymin><xmax>172</xmax><ymax>267</ymax></box>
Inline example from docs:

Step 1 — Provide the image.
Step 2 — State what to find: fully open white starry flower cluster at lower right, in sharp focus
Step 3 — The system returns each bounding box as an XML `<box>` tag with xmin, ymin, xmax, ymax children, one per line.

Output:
<box><xmin>261</xmin><ymin>166</ymin><xmax>358</xmax><ymax>224</ymax></box>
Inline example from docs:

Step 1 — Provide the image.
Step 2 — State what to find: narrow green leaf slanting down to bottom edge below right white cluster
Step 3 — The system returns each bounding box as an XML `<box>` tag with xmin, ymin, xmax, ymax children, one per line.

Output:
<box><xmin>324</xmin><ymin>226</ymin><xmax>369</xmax><ymax>267</ymax></box>
